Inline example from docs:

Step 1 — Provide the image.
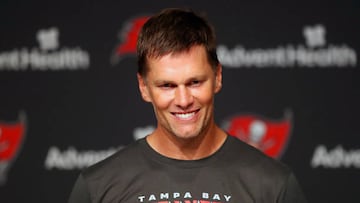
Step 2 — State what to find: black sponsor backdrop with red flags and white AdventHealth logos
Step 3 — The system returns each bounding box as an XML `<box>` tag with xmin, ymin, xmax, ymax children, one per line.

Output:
<box><xmin>0</xmin><ymin>0</ymin><xmax>360</xmax><ymax>203</ymax></box>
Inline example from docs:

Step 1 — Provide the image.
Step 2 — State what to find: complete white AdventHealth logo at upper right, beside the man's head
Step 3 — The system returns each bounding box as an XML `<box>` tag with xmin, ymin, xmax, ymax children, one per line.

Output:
<box><xmin>217</xmin><ymin>24</ymin><xmax>357</xmax><ymax>68</ymax></box>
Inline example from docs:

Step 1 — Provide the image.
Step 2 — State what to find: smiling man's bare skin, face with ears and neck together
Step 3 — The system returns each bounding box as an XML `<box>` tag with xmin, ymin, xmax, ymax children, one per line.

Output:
<box><xmin>138</xmin><ymin>45</ymin><xmax>226</xmax><ymax>160</ymax></box>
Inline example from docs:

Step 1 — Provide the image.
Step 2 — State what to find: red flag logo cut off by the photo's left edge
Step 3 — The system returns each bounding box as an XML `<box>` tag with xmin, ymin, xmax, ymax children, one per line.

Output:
<box><xmin>0</xmin><ymin>114</ymin><xmax>25</xmax><ymax>185</ymax></box>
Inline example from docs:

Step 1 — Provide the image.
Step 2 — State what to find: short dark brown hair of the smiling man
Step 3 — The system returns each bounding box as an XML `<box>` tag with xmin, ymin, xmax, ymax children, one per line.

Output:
<box><xmin>137</xmin><ymin>8</ymin><xmax>219</xmax><ymax>76</ymax></box>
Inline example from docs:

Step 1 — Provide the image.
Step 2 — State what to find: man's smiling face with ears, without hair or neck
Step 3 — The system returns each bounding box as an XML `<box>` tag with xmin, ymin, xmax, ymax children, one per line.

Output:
<box><xmin>138</xmin><ymin>46</ymin><xmax>222</xmax><ymax>139</ymax></box>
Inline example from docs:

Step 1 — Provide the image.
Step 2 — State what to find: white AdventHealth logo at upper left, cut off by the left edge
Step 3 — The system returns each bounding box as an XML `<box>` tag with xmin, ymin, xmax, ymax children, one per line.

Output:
<box><xmin>0</xmin><ymin>27</ymin><xmax>90</xmax><ymax>71</ymax></box>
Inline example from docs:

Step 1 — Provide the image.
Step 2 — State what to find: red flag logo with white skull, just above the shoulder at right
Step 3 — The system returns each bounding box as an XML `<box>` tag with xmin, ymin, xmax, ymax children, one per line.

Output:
<box><xmin>224</xmin><ymin>113</ymin><xmax>292</xmax><ymax>158</ymax></box>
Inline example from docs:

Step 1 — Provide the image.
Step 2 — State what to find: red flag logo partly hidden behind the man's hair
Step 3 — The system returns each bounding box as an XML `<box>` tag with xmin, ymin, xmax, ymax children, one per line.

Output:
<box><xmin>111</xmin><ymin>16</ymin><xmax>149</xmax><ymax>65</ymax></box>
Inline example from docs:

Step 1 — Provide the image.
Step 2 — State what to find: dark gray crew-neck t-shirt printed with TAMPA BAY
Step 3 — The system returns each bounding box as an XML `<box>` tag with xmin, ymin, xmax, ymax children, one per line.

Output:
<box><xmin>69</xmin><ymin>136</ymin><xmax>306</xmax><ymax>203</ymax></box>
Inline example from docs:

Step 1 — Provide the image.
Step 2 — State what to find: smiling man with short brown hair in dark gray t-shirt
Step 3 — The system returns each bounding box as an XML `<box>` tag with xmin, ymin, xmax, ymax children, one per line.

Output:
<box><xmin>70</xmin><ymin>9</ymin><xmax>306</xmax><ymax>203</ymax></box>
